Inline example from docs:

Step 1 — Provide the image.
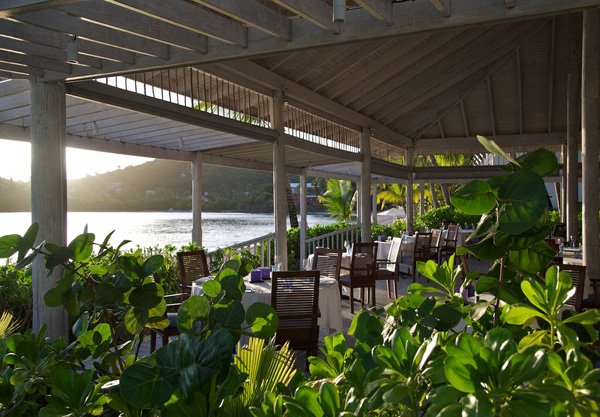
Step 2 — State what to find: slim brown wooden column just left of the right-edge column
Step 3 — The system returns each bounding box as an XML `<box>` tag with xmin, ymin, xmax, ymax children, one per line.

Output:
<box><xmin>566</xmin><ymin>13</ymin><xmax>582</xmax><ymax>242</ymax></box>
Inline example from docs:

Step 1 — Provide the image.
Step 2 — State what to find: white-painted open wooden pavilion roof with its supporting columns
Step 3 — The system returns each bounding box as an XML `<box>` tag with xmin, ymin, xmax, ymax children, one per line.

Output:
<box><xmin>0</xmin><ymin>0</ymin><xmax>600</xmax><ymax>337</ymax></box>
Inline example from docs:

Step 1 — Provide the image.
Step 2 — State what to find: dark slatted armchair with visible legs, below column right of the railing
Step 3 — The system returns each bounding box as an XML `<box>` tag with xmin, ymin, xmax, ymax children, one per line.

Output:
<box><xmin>339</xmin><ymin>243</ymin><xmax>377</xmax><ymax>314</ymax></box>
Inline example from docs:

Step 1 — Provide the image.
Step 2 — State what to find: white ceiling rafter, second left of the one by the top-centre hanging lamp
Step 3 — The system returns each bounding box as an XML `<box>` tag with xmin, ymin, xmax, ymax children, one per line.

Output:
<box><xmin>109</xmin><ymin>0</ymin><xmax>248</xmax><ymax>48</ymax></box>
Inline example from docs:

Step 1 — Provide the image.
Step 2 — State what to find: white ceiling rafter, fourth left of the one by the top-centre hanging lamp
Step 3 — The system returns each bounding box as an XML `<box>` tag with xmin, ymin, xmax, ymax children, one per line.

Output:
<box><xmin>16</xmin><ymin>10</ymin><xmax>170</xmax><ymax>59</ymax></box>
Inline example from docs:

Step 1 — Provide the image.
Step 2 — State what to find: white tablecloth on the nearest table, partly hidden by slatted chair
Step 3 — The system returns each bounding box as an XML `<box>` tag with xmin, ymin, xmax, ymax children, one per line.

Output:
<box><xmin>192</xmin><ymin>276</ymin><xmax>343</xmax><ymax>332</ymax></box>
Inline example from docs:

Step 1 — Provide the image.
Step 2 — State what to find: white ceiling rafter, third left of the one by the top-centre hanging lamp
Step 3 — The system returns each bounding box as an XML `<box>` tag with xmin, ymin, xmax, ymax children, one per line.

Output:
<box><xmin>60</xmin><ymin>0</ymin><xmax>207</xmax><ymax>54</ymax></box>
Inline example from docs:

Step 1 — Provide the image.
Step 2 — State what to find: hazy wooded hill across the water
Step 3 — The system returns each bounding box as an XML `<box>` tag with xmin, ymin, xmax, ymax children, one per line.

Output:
<box><xmin>0</xmin><ymin>159</ymin><xmax>273</xmax><ymax>212</ymax></box>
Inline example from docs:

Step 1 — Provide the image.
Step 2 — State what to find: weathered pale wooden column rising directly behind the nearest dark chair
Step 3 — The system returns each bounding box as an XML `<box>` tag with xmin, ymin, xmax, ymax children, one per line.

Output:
<box><xmin>271</xmin><ymin>91</ymin><xmax>288</xmax><ymax>270</ymax></box>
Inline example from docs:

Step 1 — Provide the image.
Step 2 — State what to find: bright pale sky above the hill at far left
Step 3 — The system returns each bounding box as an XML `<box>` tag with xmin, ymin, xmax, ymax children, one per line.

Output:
<box><xmin>0</xmin><ymin>139</ymin><xmax>152</xmax><ymax>181</ymax></box>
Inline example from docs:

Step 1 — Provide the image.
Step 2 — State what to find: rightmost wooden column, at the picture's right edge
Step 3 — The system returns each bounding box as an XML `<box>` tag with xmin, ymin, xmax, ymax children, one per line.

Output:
<box><xmin>581</xmin><ymin>9</ymin><xmax>600</xmax><ymax>278</ymax></box>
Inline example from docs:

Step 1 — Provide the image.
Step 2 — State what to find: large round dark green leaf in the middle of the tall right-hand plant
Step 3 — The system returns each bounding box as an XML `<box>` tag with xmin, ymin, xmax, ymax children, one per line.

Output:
<box><xmin>498</xmin><ymin>169</ymin><xmax>548</xmax><ymax>235</ymax></box>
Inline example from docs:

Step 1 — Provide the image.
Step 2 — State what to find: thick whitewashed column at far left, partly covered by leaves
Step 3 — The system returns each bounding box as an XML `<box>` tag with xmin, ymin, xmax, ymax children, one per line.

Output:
<box><xmin>30</xmin><ymin>78</ymin><xmax>69</xmax><ymax>340</ymax></box>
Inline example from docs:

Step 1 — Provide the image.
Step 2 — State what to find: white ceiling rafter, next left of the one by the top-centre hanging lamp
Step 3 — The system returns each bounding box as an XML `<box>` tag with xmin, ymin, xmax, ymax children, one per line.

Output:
<box><xmin>193</xmin><ymin>0</ymin><xmax>292</xmax><ymax>41</ymax></box>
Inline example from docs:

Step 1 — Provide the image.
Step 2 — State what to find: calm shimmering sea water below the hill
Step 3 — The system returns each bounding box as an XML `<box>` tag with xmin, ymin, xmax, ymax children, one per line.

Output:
<box><xmin>0</xmin><ymin>212</ymin><xmax>335</xmax><ymax>250</ymax></box>
